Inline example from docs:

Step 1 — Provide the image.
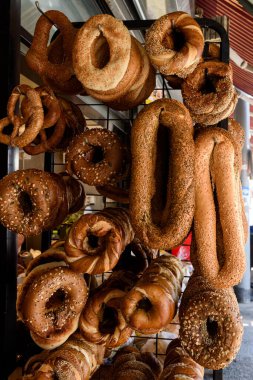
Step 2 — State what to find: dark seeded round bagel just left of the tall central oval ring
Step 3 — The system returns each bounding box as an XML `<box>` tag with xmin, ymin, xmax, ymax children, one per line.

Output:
<box><xmin>66</xmin><ymin>128</ymin><xmax>125</xmax><ymax>186</ymax></box>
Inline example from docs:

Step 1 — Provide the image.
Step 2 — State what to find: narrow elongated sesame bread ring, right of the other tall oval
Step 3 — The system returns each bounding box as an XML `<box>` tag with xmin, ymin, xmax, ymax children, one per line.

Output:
<box><xmin>194</xmin><ymin>128</ymin><xmax>246</xmax><ymax>288</ymax></box>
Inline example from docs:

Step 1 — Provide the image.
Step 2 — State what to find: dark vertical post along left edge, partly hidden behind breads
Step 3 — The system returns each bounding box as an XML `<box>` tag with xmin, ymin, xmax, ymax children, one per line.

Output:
<box><xmin>0</xmin><ymin>0</ymin><xmax>20</xmax><ymax>380</ymax></box>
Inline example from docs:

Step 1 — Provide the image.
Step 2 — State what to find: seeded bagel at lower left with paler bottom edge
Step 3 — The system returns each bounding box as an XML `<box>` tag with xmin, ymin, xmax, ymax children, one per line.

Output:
<box><xmin>17</xmin><ymin>262</ymin><xmax>87</xmax><ymax>349</ymax></box>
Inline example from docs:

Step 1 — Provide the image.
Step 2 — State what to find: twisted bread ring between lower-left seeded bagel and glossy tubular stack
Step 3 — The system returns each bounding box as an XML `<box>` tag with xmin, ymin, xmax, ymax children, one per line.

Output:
<box><xmin>79</xmin><ymin>270</ymin><xmax>137</xmax><ymax>348</ymax></box>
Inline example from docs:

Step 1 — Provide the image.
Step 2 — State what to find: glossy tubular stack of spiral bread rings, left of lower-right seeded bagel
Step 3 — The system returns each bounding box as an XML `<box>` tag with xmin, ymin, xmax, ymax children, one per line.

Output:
<box><xmin>121</xmin><ymin>255</ymin><xmax>183</xmax><ymax>334</ymax></box>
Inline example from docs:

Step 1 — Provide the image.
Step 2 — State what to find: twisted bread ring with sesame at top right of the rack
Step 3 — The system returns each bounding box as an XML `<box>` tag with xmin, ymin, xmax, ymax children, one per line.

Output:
<box><xmin>145</xmin><ymin>12</ymin><xmax>204</xmax><ymax>78</ymax></box>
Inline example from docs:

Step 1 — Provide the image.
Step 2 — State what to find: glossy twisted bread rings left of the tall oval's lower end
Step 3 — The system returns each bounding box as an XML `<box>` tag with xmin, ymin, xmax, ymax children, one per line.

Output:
<box><xmin>65</xmin><ymin>208</ymin><xmax>134</xmax><ymax>274</ymax></box>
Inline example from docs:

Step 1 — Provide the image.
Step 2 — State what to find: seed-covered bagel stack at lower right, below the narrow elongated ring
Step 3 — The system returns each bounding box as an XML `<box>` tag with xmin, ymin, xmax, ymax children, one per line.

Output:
<box><xmin>179</xmin><ymin>276</ymin><xmax>243</xmax><ymax>369</ymax></box>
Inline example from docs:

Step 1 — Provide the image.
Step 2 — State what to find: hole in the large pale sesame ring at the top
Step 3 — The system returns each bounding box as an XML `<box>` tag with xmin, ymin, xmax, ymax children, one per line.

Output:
<box><xmin>91</xmin><ymin>33</ymin><xmax>110</xmax><ymax>69</ymax></box>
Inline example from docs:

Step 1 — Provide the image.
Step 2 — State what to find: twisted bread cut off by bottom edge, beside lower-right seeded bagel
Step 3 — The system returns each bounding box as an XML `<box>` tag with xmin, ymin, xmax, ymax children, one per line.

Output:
<box><xmin>160</xmin><ymin>339</ymin><xmax>204</xmax><ymax>380</ymax></box>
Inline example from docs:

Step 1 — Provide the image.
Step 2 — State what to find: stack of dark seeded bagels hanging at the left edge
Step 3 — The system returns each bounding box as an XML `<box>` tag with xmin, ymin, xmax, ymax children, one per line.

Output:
<box><xmin>0</xmin><ymin>169</ymin><xmax>84</xmax><ymax>236</ymax></box>
